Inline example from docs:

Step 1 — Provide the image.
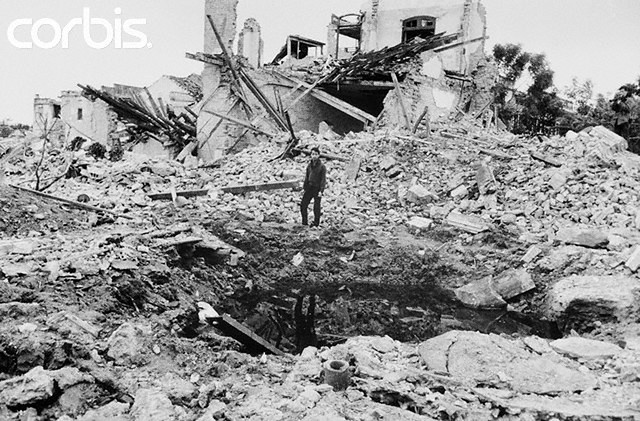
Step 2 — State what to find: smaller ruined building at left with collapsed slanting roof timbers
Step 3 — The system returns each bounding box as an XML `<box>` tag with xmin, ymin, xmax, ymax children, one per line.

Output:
<box><xmin>33</xmin><ymin>74</ymin><xmax>202</xmax><ymax>156</ymax></box>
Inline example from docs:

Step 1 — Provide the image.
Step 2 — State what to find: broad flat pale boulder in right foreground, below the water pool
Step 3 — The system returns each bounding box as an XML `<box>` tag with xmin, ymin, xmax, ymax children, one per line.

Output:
<box><xmin>419</xmin><ymin>331</ymin><xmax>597</xmax><ymax>394</ymax></box>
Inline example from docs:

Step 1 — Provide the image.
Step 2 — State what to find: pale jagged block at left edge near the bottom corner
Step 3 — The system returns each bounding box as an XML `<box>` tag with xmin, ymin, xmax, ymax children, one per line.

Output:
<box><xmin>0</xmin><ymin>367</ymin><xmax>55</xmax><ymax>407</ymax></box>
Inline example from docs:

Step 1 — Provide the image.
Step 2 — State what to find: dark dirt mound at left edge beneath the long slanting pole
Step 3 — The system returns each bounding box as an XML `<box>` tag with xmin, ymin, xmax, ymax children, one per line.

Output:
<box><xmin>0</xmin><ymin>185</ymin><xmax>87</xmax><ymax>237</ymax></box>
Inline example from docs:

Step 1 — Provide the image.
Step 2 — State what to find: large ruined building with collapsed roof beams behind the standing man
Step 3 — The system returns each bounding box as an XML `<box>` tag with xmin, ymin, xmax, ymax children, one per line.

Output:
<box><xmin>195</xmin><ymin>0</ymin><xmax>493</xmax><ymax>161</ymax></box>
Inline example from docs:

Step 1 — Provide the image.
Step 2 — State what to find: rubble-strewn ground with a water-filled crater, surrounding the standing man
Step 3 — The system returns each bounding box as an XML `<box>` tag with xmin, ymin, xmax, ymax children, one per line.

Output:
<box><xmin>0</xmin><ymin>118</ymin><xmax>640</xmax><ymax>421</ymax></box>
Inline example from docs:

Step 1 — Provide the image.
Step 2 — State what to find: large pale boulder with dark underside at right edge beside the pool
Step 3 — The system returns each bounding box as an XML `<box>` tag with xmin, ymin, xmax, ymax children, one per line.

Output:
<box><xmin>546</xmin><ymin>275</ymin><xmax>640</xmax><ymax>331</ymax></box>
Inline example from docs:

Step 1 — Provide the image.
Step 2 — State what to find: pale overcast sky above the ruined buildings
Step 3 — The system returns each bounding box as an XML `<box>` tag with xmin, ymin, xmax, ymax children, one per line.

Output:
<box><xmin>0</xmin><ymin>0</ymin><xmax>640</xmax><ymax>123</ymax></box>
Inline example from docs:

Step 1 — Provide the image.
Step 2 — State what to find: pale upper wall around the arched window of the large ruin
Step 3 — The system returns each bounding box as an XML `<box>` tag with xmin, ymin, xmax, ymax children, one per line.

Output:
<box><xmin>362</xmin><ymin>0</ymin><xmax>486</xmax><ymax>74</ymax></box>
